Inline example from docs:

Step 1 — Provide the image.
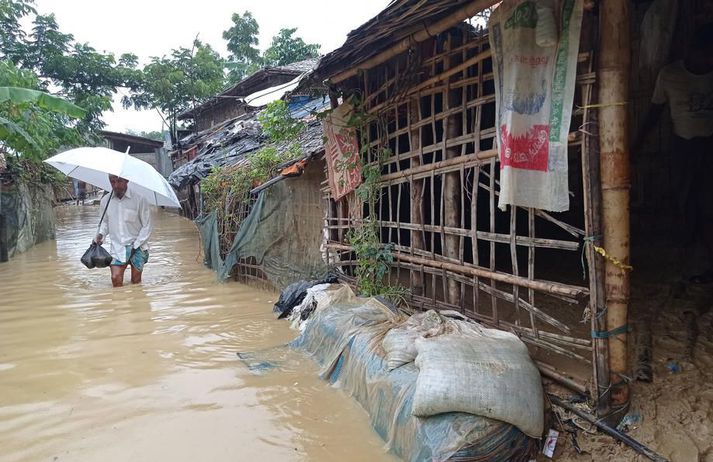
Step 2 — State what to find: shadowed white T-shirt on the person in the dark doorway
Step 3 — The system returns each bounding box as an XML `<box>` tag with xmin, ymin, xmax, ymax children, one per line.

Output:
<box><xmin>651</xmin><ymin>61</ymin><xmax>713</xmax><ymax>140</ymax></box>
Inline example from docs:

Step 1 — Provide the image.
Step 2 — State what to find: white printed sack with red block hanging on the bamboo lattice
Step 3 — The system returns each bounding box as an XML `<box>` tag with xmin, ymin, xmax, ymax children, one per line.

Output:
<box><xmin>488</xmin><ymin>0</ymin><xmax>582</xmax><ymax>212</ymax></box>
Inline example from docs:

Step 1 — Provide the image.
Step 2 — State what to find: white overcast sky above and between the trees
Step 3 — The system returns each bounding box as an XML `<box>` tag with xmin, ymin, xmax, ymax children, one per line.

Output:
<box><xmin>35</xmin><ymin>0</ymin><xmax>389</xmax><ymax>132</ymax></box>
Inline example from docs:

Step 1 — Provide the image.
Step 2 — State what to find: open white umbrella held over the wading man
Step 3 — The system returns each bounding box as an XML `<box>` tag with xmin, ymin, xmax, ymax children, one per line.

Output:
<box><xmin>45</xmin><ymin>147</ymin><xmax>181</xmax><ymax>207</ymax></box>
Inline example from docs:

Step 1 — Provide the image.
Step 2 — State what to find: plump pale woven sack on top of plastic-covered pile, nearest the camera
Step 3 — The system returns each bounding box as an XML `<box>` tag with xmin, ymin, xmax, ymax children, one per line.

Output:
<box><xmin>412</xmin><ymin>321</ymin><xmax>544</xmax><ymax>438</ymax></box>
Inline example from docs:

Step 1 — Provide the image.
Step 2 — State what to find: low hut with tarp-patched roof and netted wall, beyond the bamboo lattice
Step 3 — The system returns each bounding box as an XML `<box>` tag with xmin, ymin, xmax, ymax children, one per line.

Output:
<box><xmin>169</xmin><ymin>60</ymin><xmax>329</xmax><ymax>288</ymax></box>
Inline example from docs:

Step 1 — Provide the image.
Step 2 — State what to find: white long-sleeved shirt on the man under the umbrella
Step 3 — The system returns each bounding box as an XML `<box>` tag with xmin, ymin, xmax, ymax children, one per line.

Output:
<box><xmin>99</xmin><ymin>187</ymin><xmax>153</xmax><ymax>261</ymax></box>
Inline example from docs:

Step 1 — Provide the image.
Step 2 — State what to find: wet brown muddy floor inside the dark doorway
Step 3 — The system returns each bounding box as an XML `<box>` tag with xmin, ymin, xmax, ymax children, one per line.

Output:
<box><xmin>555</xmin><ymin>246</ymin><xmax>713</xmax><ymax>462</ymax></box>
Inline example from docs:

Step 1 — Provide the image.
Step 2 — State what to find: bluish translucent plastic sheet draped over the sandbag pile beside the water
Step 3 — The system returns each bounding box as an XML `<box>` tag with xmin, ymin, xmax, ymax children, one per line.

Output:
<box><xmin>291</xmin><ymin>285</ymin><xmax>535</xmax><ymax>462</ymax></box>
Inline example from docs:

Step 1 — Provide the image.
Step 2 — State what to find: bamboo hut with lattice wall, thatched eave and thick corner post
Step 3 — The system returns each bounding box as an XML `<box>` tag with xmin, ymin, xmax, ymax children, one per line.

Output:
<box><xmin>298</xmin><ymin>0</ymin><xmax>630</xmax><ymax>419</ymax></box>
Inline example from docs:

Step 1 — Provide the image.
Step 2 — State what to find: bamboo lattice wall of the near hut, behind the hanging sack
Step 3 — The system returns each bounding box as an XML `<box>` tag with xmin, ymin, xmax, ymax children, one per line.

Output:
<box><xmin>322</xmin><ymin>24</ymin><xmax>608</xmax><ymax>395</ymax></box>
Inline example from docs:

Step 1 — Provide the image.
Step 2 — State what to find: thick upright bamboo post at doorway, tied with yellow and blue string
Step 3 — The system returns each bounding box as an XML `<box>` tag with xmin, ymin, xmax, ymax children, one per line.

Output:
<box><xmin>599</xmin><ymin>0</ymin><xmax>631</xmax><ymax>417</ymax></box>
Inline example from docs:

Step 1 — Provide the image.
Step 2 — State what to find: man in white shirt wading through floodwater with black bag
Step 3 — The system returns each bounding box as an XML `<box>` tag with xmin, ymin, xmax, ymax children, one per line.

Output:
<box><xmin>94</xmin><ymin>175</ymin><xmax>153</xmax><ymax>287</ymax></box>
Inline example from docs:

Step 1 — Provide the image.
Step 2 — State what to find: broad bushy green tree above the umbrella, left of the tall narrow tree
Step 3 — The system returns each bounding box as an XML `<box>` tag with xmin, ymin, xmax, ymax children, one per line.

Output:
<box><xmin>122</xmin><ymin>40</ymin><xmax>225</xmax><ymax>143</ymax></box>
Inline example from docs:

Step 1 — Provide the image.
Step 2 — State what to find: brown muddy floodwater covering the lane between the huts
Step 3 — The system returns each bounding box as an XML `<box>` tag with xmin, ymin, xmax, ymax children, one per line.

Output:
<box><xmin>0</xmin><ymin>206</ymin><xmax>395</xmax><ymax>462</ymax></box>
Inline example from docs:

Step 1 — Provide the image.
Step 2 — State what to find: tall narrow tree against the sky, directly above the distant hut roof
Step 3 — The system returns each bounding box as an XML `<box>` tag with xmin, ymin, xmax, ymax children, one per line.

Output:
<box><xmin>223</xmin><ymin>11</ymin><xmax>262</xmax><ymax>82</ymax></box>
